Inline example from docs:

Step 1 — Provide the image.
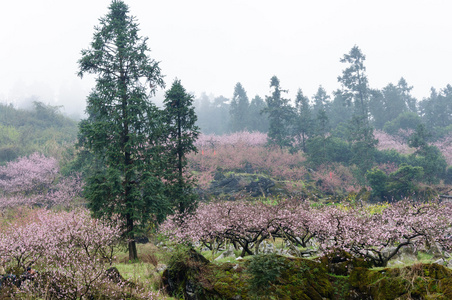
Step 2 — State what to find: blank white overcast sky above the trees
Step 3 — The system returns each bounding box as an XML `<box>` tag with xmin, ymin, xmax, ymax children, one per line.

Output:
<box><xmin>0</xmin><ymin>0</ymin><xmax>452</xmax><ymax>113</ymax></box>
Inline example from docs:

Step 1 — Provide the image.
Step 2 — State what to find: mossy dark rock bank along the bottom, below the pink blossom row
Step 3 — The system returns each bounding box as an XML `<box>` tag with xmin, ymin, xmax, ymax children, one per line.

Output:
<box><xmin>163</xmin><ymin>250</ymin><xmax>452</xmax><ymax>300</ymax></box>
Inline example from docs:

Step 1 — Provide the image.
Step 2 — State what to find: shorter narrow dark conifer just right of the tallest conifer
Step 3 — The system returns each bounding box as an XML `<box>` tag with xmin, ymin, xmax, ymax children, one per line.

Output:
<box><xmin>164</xmin><ymin>80</ymin><xmax>199</xmax><ymax>213</ymax></box>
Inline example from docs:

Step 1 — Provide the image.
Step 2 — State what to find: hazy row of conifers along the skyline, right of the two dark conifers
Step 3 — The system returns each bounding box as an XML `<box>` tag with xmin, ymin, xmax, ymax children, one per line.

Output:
<box><xmin>195</xmin><ymin>46</ymin><xmax>452</xmax><ymax>141</ymax></box>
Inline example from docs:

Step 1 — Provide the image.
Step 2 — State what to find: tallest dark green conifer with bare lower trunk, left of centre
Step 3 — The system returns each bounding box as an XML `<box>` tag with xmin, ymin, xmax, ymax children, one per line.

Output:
<box><xmin>79</xmin><ymin>0</ymin><xmax>168</xmax><ymax>260</ymax></box>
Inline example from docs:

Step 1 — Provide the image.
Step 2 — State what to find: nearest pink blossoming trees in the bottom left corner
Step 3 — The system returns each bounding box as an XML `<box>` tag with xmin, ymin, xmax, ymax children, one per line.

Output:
<box><xmin>0</xmin><ymin>209</ymin><xmax>157</xmax><ymax>299</ymax></box>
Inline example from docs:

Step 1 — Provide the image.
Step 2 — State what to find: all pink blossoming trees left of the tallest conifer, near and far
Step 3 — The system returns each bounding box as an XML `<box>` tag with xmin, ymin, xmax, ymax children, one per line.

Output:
<box><xmin>0</xmin><ymin>153</ymin><xmax>160</xmax><ymax>299</ymax></box>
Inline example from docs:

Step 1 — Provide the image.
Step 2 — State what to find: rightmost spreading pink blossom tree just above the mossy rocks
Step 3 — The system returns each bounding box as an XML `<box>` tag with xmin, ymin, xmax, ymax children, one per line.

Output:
<box><xmin>318</xmin><ymin>200</ymin><xmax>452</xmax><ymax>266</ymax></box>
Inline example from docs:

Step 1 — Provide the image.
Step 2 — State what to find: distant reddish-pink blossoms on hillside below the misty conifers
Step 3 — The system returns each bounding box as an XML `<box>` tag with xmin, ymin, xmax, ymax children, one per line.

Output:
<box><xmin>188</xmin><ymin>131</ymin><xmax>452</xmax><ymax>193</ymax></box>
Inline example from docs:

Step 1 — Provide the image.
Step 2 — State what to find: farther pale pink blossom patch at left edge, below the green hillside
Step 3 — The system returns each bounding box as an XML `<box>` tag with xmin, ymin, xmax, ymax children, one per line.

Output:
<box><xmin>0</xmin><ymin>153</ymin><xmax>82</xmax><ymax>210</ymax></box>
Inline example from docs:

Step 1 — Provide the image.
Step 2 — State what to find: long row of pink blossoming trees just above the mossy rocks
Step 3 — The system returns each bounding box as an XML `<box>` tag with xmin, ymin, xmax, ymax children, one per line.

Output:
<box><xmin>160</xmin><ymin>199</ymin><xmax>452</xmax><ymax>266</ymax></box>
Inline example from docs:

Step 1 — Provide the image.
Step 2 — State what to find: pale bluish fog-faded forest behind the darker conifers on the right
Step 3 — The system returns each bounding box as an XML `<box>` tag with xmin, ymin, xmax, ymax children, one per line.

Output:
<box><xmin>195</xmin><ymin>49</ymin><xmax>452</xmax><ymax>140</ymax></box>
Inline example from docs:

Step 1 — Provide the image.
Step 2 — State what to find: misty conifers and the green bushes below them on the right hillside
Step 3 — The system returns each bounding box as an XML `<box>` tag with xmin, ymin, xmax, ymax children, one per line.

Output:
<box><xmin>195</xmin><ymin>46</ymin><xmax>452</xmax><ymax>191</ymax></box>
